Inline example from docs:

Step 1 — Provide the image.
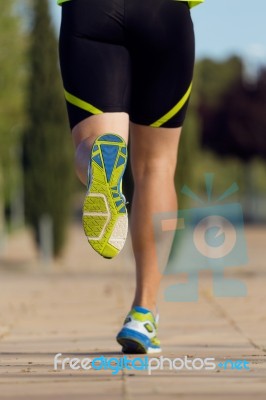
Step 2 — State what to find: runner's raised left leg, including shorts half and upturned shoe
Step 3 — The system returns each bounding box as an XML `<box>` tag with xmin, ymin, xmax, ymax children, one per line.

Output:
<box><xmin>59</xmin><ymin>0</ymin><xmax>130</xmax><ymax>258</ymax></box>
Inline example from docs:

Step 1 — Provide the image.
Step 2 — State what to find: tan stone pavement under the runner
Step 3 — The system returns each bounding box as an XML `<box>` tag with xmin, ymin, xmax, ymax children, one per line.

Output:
<box><xmin>0</xmin><ymin>227</ymin><xmax>266</xmax><ymax>400</ymax></box>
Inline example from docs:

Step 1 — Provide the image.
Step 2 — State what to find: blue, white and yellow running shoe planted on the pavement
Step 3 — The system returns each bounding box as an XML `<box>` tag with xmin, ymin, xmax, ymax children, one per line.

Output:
<box><xmin>116</xmin><ymin>306</ymin><xmax>161</xmax><ymax>354</ymax></box>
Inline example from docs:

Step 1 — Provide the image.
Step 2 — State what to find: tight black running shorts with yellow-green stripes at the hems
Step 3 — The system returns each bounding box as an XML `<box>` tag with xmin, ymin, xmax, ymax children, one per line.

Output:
<box><xmin>59</xmin><ymin>0</ymin><xmax>195</xmax><ymax>128</ymax></box>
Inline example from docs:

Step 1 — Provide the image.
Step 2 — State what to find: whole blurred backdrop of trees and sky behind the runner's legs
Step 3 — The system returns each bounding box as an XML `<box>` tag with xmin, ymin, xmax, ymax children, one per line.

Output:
<box><xmin>0</xmin><ymin>0</ymin><xmax>266</xmax><ymax>268</ymax></box>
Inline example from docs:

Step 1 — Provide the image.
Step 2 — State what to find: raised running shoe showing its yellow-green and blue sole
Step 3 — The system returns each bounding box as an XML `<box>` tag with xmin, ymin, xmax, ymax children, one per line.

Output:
<box><xmin>82</xmin><ymin>134</ymin><xmax>128</xmax><ymax>258</ymax></box>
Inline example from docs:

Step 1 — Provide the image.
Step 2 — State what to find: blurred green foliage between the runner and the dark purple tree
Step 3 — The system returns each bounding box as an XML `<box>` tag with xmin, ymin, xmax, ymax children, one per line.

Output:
<box><xmin>176</xmin><ymin>57</ymin><xmax>246</xmax><ymax>209</ymax></box>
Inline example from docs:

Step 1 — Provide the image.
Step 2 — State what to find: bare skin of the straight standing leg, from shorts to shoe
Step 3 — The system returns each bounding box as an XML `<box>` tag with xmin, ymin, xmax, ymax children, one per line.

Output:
<box><xmin>130</xmin><ymin>124</ymin><xmax>181</xmax><ymax>311</ymax></box>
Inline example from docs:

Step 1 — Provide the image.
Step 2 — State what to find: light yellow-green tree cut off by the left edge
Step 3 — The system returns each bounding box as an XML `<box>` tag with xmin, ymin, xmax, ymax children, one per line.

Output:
<box><xmin>0</xmin><ymin>0</ymin><xmax>27</xmax><ymax>206</ymax></box>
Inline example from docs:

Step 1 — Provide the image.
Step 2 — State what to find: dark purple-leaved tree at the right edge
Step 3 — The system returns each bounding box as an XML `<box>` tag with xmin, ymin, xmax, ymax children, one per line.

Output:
<box><xmin>202</xmin><ymin>66</ymin><xmax>266</xmax><ymax>162</ymax></box>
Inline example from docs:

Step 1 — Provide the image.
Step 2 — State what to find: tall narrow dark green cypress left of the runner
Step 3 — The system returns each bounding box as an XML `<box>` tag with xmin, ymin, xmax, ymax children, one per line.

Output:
<box><xmin>23</xmin><ymin>0</ymin><xmax>73</xmax><ymax>256</ymax></box>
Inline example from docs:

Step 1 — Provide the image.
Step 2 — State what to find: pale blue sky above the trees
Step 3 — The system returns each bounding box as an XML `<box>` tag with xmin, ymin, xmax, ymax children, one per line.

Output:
<box><xmin>51</xmin><ymin>0</ymin><xmax>266</xmax><ymax>64</ymax></box>
